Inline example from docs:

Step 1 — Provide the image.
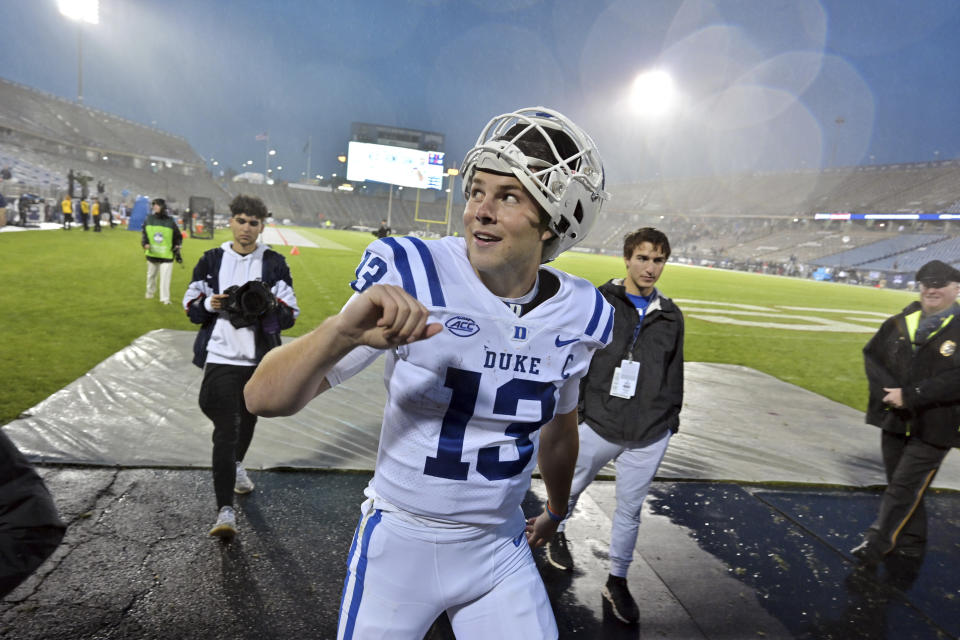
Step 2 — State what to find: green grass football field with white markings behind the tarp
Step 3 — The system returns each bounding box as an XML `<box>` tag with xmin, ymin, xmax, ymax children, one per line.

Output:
<box><xmin>0</xmin><ymin>228</ymin><xmax>916</xmax><ymax>424</ymax></box>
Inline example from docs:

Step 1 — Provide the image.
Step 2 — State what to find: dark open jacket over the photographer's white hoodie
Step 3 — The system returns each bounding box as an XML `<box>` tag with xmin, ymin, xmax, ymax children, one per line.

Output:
<box><xmin>187</xmin><ymin>247</ymin><xmax>296</xmax><ymax>369</ymax></box>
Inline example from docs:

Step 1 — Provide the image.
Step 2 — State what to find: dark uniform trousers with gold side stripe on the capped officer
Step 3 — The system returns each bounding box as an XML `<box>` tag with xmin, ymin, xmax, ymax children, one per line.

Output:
<box><xmin>868</xmin><ymin>431</ymin><xmax>950</xmax><ymax>553</ymax></box>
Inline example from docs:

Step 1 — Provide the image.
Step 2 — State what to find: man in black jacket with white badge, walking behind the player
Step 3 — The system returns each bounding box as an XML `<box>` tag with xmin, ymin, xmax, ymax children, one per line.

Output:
<box><xmin>547</xmin><ymin>227</ymin><xmax>683</xmax><ymax>624</ymax></box>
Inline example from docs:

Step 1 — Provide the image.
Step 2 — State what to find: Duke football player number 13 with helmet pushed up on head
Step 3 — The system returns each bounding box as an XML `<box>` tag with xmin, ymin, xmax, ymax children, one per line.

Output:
<box><xmin>245</xmin><ymin>107</ymin><xmax>613</xmax><ymax>640</ymax></box>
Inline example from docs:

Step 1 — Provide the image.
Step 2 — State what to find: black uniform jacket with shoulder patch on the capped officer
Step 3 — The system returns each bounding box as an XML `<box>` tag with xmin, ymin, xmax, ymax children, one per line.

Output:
<box><xmin>863</xmin><ymin>302</ymin><xmax>960</xmax><ymax>447</ymax></box>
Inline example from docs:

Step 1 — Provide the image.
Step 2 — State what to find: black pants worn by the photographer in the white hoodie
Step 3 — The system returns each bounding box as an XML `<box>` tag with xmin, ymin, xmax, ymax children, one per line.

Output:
<box><xmin>200</xmin><ymin>363</ymin><xmax>257</xmax><ymax>509</ymax></box>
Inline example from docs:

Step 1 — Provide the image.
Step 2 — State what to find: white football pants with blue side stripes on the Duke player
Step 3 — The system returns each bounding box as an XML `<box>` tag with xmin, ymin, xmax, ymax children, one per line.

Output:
<box><xmin>337</xmin><ymin>499</ymin><xmax>558</xmax><ymax>640</ymax></box>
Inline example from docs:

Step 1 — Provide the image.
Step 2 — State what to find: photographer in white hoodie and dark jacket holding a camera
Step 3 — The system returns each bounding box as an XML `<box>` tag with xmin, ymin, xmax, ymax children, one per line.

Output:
<box><xmin>183</xmin><ymin>195</ymin><xmax>300</xmax><ymax>538</ymax></box>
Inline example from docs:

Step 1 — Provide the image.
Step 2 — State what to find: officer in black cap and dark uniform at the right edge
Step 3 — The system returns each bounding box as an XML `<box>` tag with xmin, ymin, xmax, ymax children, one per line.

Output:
<box><xmin>850</xmin><ymin>260</ymin><xmax>960</xmax><ymax>565</ymax></box>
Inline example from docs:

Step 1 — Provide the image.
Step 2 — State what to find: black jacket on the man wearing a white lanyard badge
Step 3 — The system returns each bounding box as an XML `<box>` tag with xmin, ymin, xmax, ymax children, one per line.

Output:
<box><xmin>580</xmin><ymin>279</ymin><xmax>683</xmax><ymax>444</ymax></box>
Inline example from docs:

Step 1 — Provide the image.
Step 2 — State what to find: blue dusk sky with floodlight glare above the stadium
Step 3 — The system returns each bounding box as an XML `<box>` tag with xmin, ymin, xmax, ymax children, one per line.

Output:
<box><xmin>0</xmin><ymin>0</ymin><xmax>960</xmax><ymax>184</ymax></box>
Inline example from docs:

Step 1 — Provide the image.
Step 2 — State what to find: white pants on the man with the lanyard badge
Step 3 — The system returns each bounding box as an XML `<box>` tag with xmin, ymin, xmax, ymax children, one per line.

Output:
<box><xmin>557</xmin><ymin>422</ymin><xmax>673</xmax><ymax>578</ymax></box>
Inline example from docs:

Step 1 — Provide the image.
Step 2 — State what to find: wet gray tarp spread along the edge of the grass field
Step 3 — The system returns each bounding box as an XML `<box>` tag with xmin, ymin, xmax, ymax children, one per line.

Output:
<box><xmin>4</xmin><ymin>329</ymin><xmax>960</xmax><ymax>490</ymax></box>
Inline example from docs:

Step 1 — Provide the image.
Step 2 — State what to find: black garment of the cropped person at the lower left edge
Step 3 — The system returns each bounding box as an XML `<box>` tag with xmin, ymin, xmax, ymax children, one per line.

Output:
<box><xmin>0</xmin><ymin>433</ymin><xmax>67</xmax><ymax>598</ymax></box>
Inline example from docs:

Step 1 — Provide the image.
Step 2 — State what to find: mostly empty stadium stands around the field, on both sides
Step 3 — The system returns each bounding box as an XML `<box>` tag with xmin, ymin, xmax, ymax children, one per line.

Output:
<box><xmin>0</xmin><ymin>71</ymin><xmax>960</xmax><ymax>282</ymax></box>
